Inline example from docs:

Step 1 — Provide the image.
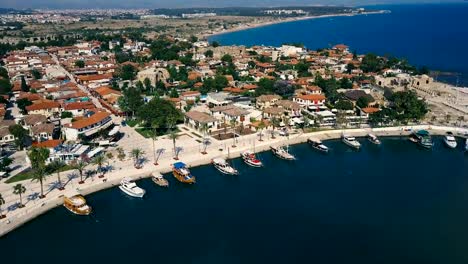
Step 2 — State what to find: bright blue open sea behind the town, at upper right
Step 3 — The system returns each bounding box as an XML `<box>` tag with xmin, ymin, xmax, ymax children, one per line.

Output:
<box><xmin>209</xmin><ymin>2</ymin><xmax>468</xmax><ymax>87</ymax></box>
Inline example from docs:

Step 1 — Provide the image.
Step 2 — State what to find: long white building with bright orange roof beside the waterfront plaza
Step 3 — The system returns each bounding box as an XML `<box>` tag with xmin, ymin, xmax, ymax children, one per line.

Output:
<box><xmin>63</xmin><ymin>111</ymin><xmax>113</xmax><ymax>140</ymax></box>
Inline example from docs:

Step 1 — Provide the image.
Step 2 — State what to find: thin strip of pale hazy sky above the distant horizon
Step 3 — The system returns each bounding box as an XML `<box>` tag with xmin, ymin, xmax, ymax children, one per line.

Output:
<box><xmin>0</xmin><ymin>0</ymin><xmax>463</xmax><ymax>9</ymax></box>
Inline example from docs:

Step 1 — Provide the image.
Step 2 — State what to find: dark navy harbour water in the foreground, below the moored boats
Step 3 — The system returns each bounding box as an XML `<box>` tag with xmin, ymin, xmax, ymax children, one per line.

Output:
<box><xmin>0</xmin><ymin>137</ymin><xmax>468</xmax><ymax>264</ymax></box>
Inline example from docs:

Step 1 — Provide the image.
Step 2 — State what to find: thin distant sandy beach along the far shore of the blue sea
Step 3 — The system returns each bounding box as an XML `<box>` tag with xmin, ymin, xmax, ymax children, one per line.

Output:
<box><xmin>201</xmin><ymin>10</ymin><xmax>390</xmax><ymax>38</ymax></box>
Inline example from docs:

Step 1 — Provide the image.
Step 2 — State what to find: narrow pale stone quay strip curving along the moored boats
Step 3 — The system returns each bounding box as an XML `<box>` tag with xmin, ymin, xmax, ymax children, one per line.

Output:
<box><xmin>0</xmin><ymin>125</ymin><xmax>468</xmax><ymax>237</ymax></box>
